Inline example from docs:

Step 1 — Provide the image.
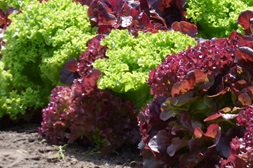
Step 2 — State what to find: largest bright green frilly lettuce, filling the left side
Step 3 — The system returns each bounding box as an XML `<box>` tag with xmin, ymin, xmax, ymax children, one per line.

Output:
<box><xmin>1</xmin><ymin>0</ymin><xmax>95</xmax><ymax>119</ymax></box>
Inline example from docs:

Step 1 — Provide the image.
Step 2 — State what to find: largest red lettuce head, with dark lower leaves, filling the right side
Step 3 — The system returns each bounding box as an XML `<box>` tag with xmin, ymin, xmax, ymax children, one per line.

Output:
<box><xmin>138</xmin><ymin>28</ymin><xmax>253</xmax><ymax>168</ymax></box>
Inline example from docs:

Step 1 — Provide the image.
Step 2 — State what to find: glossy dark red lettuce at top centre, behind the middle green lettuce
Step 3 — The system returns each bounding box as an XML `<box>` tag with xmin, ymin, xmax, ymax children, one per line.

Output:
<box><xmin>87</xmin><ymin>0</ymin><xmax>186</xmax><ymax>35</ymax></box>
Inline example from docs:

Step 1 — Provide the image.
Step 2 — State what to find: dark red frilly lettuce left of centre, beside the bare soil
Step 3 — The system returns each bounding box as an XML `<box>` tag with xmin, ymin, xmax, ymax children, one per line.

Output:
<box><xmin>39</xmin><ymin>35</ymin><xmax>140</xmax><ymax>152</ymax></box>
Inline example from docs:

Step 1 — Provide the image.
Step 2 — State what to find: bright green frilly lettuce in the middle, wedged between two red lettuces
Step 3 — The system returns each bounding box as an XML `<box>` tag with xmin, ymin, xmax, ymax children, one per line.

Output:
<box><xmin>93</xmin><ymin>30</ymin><xmax>196</xmax><ymax>107</ymax></box>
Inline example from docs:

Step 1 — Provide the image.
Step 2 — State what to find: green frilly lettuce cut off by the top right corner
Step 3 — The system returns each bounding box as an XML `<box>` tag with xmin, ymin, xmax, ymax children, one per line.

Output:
<box><xmin>186</xmin><ymin>0</ymin><xmax>253</xmax><ymax>38</ymax></box>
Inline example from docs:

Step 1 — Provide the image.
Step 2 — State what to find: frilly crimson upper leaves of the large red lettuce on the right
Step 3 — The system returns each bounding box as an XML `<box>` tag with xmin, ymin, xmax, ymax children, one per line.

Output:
<box><xmin>148</xmin><ymin>39</ymin><xmax>234</xmax><ymax>96</ymax></box>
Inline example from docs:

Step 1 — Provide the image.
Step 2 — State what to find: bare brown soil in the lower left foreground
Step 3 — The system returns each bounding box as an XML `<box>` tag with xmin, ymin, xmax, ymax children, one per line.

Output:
<box><xmin>0</xmin><ymin>124</ymin><xmax>141</xmax><ymax>168</ymax></box>
